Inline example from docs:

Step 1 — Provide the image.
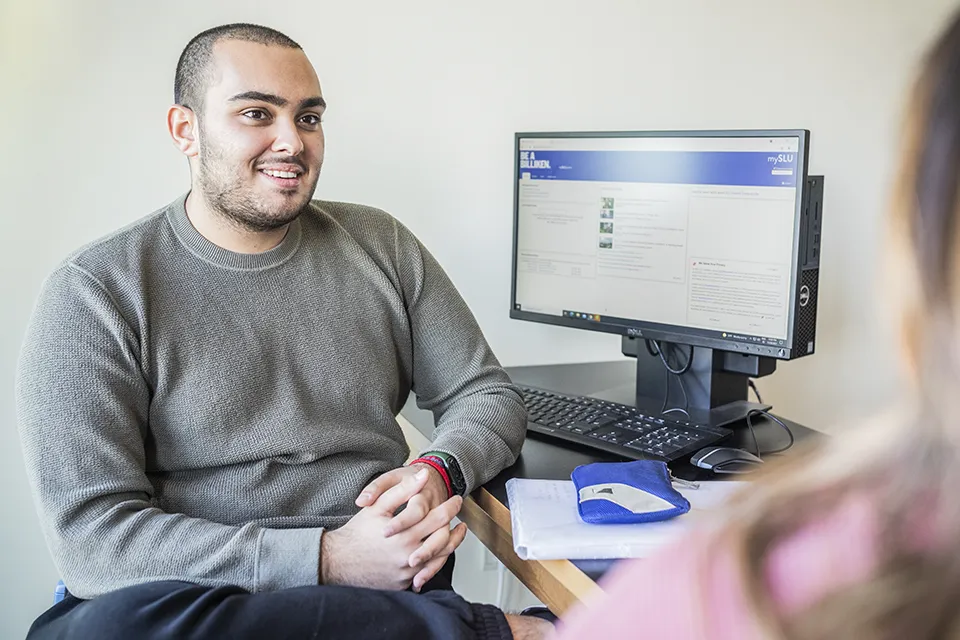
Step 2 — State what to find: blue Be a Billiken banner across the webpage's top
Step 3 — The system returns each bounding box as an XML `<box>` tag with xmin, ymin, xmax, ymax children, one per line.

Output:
<box><xmin>519</xmin><ymin>151</ymin><xmax>798</xmax><ymax>187</ymax></box>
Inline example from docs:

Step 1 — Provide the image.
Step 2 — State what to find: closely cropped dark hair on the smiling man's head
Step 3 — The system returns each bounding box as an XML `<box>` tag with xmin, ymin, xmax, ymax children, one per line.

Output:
<box><xmin>173</xmin><ymin>22</ymin><xmax>302</xmax><ymax>114</ymax></box>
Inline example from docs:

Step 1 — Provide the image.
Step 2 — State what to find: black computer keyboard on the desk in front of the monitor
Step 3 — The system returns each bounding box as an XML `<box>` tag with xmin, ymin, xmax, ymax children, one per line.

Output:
<box><xmin>518</xmin><ymin>385</ymin><xmax>733</xmax><ymax>462</ymax></box>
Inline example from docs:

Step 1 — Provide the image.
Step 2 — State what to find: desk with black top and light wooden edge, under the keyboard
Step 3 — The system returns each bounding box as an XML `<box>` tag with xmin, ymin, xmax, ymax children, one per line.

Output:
<box><xmin>400</xmin><ymin>359</ymin><xmax>816</xmax><ymax>615</ymax></box>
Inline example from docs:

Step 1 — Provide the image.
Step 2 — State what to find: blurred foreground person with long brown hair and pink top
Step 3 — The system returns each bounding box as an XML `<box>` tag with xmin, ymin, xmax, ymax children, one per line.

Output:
<box><xmin>555</xmin><ymin>10</ymin><xmax>960</xmax><ymax>640</ymax></box>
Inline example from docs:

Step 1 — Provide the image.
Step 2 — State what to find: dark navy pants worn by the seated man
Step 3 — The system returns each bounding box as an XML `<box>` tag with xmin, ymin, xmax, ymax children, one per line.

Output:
<box><xmin>27</xmin><ymin>557</ymin><xmax>512</xmax><ymax>640</ymax></box>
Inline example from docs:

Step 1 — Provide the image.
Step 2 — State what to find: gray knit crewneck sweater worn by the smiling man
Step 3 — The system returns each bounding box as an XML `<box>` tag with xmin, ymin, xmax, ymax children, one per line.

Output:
<box><xmin>17</xmin><ymin>197</ymin><xmax>526</xmax><ymax>598</ymax></box>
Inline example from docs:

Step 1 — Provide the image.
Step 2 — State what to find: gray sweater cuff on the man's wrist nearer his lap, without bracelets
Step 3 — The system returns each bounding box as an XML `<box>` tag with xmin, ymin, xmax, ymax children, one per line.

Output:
<box><xmin>254</xmin><ymin>529</ymin><xmax>323</xmax><ymax>592</ymax></box>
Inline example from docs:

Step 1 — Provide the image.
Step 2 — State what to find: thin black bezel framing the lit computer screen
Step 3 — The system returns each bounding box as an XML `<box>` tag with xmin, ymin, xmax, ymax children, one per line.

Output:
<box><xmin>510</xmin><ymin>129</ymin><xmax>810</xmax><ymax>360</ymax></box>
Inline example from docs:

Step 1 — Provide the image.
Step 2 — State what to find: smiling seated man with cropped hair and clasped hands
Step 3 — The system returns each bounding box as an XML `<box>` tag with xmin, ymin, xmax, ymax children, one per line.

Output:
<box><xmin>17</xmin><ymin>25</ymin><xmax>546</xmax><ymax>638</ymax></box>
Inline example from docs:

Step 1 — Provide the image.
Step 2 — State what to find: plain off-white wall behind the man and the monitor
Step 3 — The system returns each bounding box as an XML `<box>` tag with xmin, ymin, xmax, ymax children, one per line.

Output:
<box><xmin>0</xmin><ymin>0</ymin><xmax>953</xmax><ymax>637</ymax></box>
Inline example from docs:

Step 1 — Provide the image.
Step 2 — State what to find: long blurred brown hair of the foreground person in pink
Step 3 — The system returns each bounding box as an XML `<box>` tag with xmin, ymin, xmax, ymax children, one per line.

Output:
<box><xmin>720</xmin><ymin>11</ymin><xmax>960</xmax><ymax>640</ymax></box>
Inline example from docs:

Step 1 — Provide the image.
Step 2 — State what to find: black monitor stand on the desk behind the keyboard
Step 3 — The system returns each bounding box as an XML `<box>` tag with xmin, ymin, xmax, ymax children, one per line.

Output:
<box><xmin>623</xmin><ymin>337</ymin><xmax>777</xmax><ymax>427</ymax></box>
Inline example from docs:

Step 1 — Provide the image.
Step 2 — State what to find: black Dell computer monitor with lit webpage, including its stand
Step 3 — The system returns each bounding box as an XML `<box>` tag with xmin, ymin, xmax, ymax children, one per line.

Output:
<box><xmin>510</xmin><ymin>130</ymin><xmax>823</xmax><ymax>423</ymax></box>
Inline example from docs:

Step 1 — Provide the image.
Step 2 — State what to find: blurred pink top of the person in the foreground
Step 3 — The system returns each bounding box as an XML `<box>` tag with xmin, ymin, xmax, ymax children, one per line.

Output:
<box><xmin>556</xmin><ymin>497</ymin><xmax>877</xmax><ymax>640</ymax></box>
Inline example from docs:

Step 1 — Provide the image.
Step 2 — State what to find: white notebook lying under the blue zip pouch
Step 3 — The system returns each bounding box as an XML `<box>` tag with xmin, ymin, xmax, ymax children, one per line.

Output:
<box><xmin>507</xmin><ymin>478</ymin><xmax>746</xmax><ymax>560</ymax></box>
